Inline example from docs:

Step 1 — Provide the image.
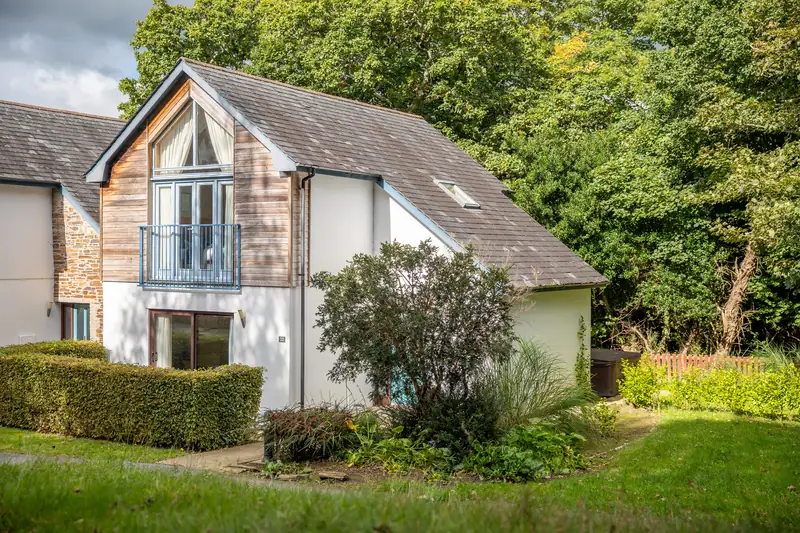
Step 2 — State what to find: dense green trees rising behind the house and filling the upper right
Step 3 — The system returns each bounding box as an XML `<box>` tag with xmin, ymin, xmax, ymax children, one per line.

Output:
<box><xmin>121</xmin><ymin>0</ymin><xmax>800</xmax><ymax>352</ymax></box>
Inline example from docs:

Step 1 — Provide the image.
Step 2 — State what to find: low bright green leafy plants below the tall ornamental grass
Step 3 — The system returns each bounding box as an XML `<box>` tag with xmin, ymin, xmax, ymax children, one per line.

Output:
<box><xmin>464</xmin><ymin>420</ymin><xmax>586</xmax><ymax>481</ymax></box>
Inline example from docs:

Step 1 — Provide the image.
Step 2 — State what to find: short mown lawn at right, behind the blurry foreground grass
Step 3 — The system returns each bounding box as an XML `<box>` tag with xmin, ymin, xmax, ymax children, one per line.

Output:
<box><xmin>381</xmin><ymin>410</ymin><xmax>800</xmax><ymax>530</ymax></box>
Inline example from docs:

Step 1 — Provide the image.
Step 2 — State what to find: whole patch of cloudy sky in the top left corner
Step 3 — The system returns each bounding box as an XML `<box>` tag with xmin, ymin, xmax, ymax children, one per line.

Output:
<box><xmin>0</xmin><ymin>0</ymin><xmax>192</xmax><ymax>116</ymax></box>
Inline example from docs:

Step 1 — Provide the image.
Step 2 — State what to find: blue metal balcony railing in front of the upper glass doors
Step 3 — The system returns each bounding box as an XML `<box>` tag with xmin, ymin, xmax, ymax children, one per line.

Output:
<box><xmin>139</xmin><ymin>224</ymin><xmax>242</xmax><ymax>290</ymax></box>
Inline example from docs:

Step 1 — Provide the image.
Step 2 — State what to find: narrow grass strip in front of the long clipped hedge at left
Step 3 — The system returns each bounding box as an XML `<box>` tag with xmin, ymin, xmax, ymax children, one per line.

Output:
<box><xmin>0</xmin><ymin>427</ymin><xmax>182</xmax><ymax>463</ymax></box>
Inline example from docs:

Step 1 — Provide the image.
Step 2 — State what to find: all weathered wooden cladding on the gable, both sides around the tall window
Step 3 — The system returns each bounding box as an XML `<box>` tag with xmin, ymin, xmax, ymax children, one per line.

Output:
<box><xmin>100</xmin><ymin>80</ymin><xmax>300</xmax><ymax>287</ymax></box>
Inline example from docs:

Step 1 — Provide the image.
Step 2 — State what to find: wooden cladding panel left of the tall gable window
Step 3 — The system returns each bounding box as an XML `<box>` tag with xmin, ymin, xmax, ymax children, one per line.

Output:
<box><xmin>100</xmin><ymin>131</ymin><xmax>150</xmax><ymax>282</ymax></box>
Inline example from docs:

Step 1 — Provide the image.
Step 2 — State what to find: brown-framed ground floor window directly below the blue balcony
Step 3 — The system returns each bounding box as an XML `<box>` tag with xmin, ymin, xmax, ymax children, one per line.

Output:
<box><xmin>150</xmin><ymin>311</ymin><xmax>233</xmax><ymax>370</ymax></box>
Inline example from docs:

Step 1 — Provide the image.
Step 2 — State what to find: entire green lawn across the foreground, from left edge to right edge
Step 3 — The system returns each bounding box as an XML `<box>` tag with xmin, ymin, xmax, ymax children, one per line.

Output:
<box><xmin>0</xmin><ymin>412</ymin><xmax>800</xmax><ymax>533</ymax></box>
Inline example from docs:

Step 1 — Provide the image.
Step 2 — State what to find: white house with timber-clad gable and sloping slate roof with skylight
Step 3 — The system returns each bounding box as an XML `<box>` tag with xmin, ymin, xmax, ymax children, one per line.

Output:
<box><xmin>86</xmin><ymin>59</ymin><xmax>606</xmax><ymax>407</ymax></box>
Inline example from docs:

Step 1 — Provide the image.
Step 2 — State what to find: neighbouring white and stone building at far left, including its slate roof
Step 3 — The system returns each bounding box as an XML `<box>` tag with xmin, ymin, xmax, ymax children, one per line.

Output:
<box><xmin>0</xmin><ymin>101</ymin><xmax>123</xmax><ymax>346</ymax></box>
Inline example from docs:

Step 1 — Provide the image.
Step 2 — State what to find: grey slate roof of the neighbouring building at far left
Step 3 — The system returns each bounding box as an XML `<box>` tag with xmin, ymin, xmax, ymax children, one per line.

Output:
<box><xmin>0</xmin><ymin>100</ymin><xmax>124</xmax><ymax>221</ymax></box>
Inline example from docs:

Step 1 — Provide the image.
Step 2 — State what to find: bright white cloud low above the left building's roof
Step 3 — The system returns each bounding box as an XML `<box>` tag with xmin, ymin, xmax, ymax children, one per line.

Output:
<box><xmin>0</xmin><ymin>59</ymin><xmax>123</xmax><ymax>116</ymax></box>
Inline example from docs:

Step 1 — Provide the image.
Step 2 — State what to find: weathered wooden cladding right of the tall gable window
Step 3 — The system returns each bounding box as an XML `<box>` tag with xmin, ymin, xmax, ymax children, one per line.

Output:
<box><xmin>233</xmin><ymin>124</ymin><xmax>292</xmax><ymax>286</ymax></box>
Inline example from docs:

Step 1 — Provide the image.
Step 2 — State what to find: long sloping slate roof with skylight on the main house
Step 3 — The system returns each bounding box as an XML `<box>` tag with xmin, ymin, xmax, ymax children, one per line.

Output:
<box><xmin>183</xmin><ymin>59</ymin><xmax>607</xmax><ymax>287</ymax></box>
